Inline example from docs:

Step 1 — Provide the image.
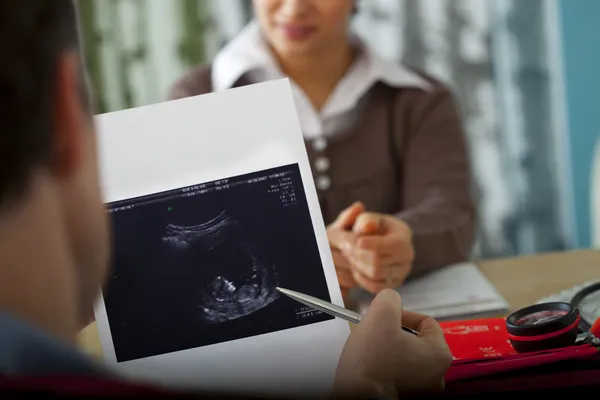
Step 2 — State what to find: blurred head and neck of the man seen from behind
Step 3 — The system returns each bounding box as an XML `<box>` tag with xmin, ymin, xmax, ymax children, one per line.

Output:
<box><xmin>0</xmin><ymin>0</ymin><xmax>109</xmax><ymax>336</ymax></box>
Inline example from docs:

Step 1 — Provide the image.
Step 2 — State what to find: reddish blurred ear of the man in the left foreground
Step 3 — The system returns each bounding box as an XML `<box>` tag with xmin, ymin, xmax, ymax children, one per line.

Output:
<box><xmin>52</xmin><ymin>51</ymin><xmax>89</xmax><ymax>178</ymax></box>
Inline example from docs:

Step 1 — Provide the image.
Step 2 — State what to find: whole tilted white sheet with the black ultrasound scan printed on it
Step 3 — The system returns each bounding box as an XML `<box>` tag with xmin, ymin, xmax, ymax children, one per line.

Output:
<box><xmin>95</xmin><ymin>80</ymin><xmax>349</xmax><ymax>393</ymax></box>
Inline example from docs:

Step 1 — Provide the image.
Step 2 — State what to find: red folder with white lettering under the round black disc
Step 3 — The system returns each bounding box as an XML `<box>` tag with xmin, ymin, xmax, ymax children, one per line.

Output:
<box><xmin>441</xmin><ymin>318</ymin><xmax>600</xmax><ymax>393</ymax></box>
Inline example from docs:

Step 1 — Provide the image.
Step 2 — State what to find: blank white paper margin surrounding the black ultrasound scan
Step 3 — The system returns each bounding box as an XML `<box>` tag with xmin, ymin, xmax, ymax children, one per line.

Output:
<box><xmin>95</xmin><ymin>79</ymin><xmax>349</xmax><ymax>392</ymax></box>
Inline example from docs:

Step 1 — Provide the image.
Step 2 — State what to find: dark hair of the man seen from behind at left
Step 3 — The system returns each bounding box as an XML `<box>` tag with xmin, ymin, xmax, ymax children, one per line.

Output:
<box><xmin>0</xmin><ymin>0</ymin><xmax>86</xmax><ymax>208</ymax></box>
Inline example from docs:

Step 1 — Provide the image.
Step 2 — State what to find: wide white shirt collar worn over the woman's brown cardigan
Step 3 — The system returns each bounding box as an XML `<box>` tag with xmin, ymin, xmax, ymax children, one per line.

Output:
<box><xmin>212</xmin><ymin>21</ymin><xmax>431</xmax><ymax>142</ymax></box>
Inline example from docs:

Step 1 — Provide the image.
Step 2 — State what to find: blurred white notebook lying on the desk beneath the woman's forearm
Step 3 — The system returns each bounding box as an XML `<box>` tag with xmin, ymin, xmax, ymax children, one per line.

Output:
<box><xmin>351</xmin><ymin>263</ymin><xmax>509</xmax><ymax>321</ymax></box>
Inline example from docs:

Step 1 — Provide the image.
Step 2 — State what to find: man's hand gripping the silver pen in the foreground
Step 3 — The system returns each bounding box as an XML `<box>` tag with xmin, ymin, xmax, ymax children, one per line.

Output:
<box><xmin>336</xmin><ymin>290</ymin><xmax>452</xmax><ymax>397</ymax></box>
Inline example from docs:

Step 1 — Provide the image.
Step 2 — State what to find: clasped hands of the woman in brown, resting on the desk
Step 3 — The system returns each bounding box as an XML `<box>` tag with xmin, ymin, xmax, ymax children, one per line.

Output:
<box><xmin>328</xmin><ymin>203</ymin><xmax>414</xmax><ymax>293</ymax></box>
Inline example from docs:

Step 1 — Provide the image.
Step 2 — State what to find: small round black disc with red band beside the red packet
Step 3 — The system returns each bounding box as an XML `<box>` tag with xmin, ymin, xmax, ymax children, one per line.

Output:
<box><xmin>506</xmin><ymin>302</ymin><xmax>581</xmax><ymax>353</ymax></box>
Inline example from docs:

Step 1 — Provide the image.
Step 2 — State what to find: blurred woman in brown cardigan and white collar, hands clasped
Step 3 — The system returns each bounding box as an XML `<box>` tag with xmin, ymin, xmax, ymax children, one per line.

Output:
<box><xmin>170</xmin><ymin>0</ymin><xmax>476</xmax><ymax>293</ymax></box>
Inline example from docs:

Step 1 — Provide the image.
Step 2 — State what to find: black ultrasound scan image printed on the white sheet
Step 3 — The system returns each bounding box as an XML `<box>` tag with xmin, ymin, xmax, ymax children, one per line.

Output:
<box><xmin>103</xmin><ymin>164</ymin><xmax>333</xmax><ymax>362</ymax></box>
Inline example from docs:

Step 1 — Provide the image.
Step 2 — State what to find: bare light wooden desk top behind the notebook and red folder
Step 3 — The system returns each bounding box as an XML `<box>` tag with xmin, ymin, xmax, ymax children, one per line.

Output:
<box><xmin>79</xmin><ymin>250</ymin><xmax>600</xmax><ymax>358</ymax></box>
